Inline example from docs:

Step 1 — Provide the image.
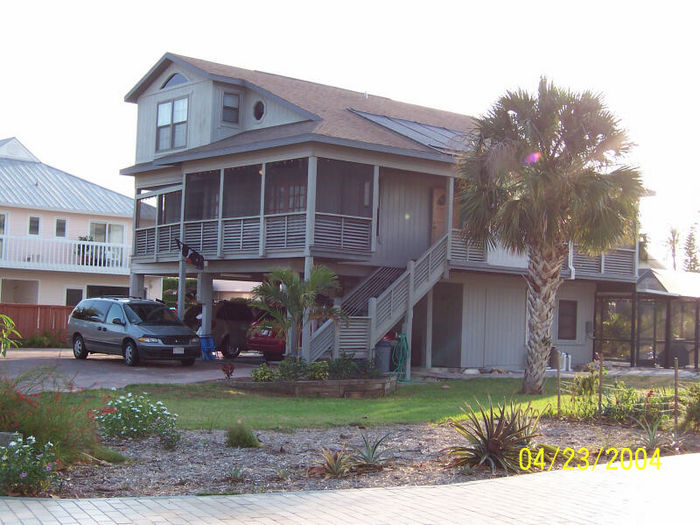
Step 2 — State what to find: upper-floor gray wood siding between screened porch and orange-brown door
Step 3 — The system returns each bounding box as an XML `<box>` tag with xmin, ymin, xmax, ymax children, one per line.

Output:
<box><xmin>371</xmin><ymin>169</ymin><xmax>445</xmax><ymax>267</ymax></box>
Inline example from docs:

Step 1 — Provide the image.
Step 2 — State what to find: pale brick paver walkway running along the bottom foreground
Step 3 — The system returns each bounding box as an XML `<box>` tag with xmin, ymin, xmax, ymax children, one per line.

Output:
<box><xmin>0</xmin><ymin>454</ymin><xmax>700</xmax><ymax>525</ymax></box>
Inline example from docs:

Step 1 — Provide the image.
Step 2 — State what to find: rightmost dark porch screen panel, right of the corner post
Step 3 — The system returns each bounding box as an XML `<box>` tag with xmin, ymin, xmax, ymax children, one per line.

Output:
<box><xmin>316</xmin><ymin>159</ymin><xmax>374</xmax><ymax>217</ymax></box>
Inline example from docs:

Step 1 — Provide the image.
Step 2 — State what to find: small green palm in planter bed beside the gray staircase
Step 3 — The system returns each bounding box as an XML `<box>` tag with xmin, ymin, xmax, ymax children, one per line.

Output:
<box><xmin>250</xmin><ymin>266</ymin><xmax>343</xmax><ymax>357</ymax></box>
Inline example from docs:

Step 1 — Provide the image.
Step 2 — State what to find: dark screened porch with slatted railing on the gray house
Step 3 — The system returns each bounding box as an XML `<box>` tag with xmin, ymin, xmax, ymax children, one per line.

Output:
<box><xmin>134</xmin><ymin>157</ymin><xmax>376</xmax><ymax>259</ymax></box>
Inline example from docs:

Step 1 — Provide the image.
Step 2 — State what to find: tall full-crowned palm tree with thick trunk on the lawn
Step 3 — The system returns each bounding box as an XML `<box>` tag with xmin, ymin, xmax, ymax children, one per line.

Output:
<box><xmin>458</xmin><ymin>78</ymin><xmax>643</xmax><ymax>393</ymax></box>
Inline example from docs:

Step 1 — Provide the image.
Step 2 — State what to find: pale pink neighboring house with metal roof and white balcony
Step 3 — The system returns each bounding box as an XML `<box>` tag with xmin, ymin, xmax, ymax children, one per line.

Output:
<box><xmin>0</xmin><ymin>138</ymin><xmax>161</xmax><ymax>306</ymax></box>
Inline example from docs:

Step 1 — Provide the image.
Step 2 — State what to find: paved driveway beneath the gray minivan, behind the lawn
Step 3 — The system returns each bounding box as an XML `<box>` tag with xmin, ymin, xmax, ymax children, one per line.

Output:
<box><xmin>0</xmin><ymin>348</ymin><xmax>260</xmax><ymax>390</ymax></box>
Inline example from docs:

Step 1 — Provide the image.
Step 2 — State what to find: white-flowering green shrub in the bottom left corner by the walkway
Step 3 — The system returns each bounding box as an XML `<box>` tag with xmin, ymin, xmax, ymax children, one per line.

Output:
<box><xmin>0</xmin><ymin>436</ymin><xmax>59</xmax><ymax>495</ymax></box>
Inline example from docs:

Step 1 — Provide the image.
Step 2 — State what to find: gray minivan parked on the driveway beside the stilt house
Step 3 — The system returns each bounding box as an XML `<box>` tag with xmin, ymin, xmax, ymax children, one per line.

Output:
<box><xmin>66</xmin><ymin>297</ymin><xmax>201</xmax><ymax>366</ymax></box>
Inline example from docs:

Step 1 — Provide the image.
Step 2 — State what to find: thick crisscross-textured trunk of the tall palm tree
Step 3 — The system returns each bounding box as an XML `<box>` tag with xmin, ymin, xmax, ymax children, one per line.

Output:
<box><xmin>523</xmin><ymin>245</ymin><xmax>566</xmax><ymax>394</ymax></box>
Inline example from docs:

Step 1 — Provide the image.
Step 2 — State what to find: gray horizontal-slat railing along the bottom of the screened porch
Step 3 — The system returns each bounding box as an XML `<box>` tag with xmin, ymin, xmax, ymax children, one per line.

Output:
<box><xmin>134</xmin><ymin>211</ymin><xmax>372</xmax><ymax>259</ymax></box>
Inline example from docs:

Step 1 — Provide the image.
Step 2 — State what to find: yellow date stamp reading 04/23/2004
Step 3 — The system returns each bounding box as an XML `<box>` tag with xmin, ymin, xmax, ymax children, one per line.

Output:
<box><xmin>520</xmin><ymin>447</ymin><xmax>661</xmax><ymax>470</ymax></box>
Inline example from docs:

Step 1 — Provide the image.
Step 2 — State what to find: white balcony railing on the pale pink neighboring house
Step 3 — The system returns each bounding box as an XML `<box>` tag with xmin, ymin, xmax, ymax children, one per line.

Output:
<box><xmin>0</xmin><ymin>235</ymin><xmax>131</xmax><ymax>275</ymax></box>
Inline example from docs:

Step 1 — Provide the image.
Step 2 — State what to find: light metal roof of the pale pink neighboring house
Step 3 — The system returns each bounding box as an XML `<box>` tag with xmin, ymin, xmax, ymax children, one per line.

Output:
<box><xmin>0</xmin><ymin>138</ymin><xmax>134</xmax><ymax>217</ymax></box>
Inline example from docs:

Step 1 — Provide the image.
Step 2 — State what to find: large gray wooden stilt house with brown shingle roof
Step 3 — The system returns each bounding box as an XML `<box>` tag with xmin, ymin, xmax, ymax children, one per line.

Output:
<box><xmin>122</xmin><ymin>53</ymin><xmax>637</xmax><ymax>368</ymax></box>
